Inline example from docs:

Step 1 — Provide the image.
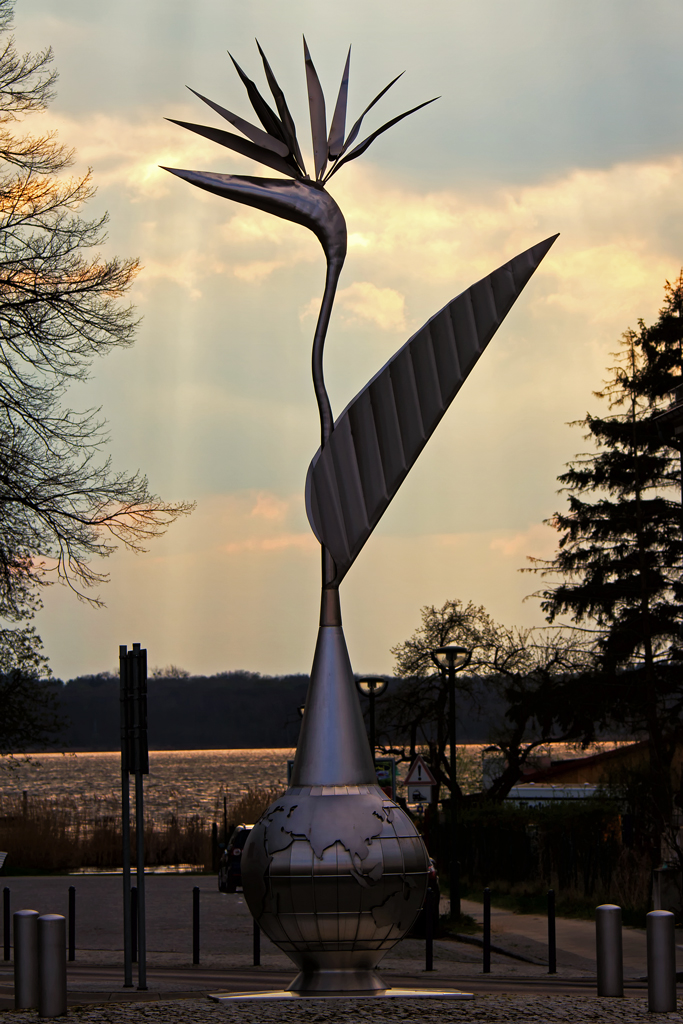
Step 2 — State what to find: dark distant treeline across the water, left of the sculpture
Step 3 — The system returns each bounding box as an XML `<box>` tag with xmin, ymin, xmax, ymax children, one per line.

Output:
<box><xmin>49</xmin><ymin>672</ymin><xmax>308</xmax><ymax>751</ymax></box>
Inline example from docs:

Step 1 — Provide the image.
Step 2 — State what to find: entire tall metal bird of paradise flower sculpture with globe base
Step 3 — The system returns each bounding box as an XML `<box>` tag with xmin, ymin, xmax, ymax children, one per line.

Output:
<box><xmin>166</xmin><ymin>40</ymin><xmax>556</xmax><ymax>994</ymax></box>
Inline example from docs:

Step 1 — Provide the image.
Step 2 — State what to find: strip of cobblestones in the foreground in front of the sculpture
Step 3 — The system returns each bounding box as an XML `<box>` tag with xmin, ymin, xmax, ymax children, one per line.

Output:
<box><xmin>0</xmin><ymin>995</ymin><xmax>683</xmax><ymax>1024</ymax></box>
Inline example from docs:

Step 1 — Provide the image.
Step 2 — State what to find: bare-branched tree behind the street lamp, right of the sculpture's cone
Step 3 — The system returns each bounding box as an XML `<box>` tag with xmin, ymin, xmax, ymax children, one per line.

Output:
<box><xmin>382</xmin><ymin>600</ymin><xmax>594</xmax><ymax>800</ymax></box>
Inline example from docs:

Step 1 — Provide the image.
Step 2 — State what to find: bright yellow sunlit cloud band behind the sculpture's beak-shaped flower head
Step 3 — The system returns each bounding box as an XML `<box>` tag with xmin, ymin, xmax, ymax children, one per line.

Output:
<box><xmin>32</xmin><ymin>104</ymin><xmax>683</xmax><ymax>331</ymax></box>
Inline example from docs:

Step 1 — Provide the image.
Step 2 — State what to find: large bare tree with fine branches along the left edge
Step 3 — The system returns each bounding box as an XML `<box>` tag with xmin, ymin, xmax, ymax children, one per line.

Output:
<box><xmin>0</xmin><ymin>0</ymin><xmax>191</xmax><ymax>622</ymax></box>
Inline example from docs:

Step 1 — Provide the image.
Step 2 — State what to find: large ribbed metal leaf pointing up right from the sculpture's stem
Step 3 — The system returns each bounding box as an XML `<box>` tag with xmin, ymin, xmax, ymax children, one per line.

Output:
<box><xmin>306</xmin><ymin>236</ymin><xmax>557</xmax><ymax>584</ymax></box>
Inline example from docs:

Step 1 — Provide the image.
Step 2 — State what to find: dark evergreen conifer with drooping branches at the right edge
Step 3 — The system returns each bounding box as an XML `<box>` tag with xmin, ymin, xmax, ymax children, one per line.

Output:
<box><xmin>535</xmin><ymin>278</ymin><xmax>683</xmax><ymax>859</ymax></box>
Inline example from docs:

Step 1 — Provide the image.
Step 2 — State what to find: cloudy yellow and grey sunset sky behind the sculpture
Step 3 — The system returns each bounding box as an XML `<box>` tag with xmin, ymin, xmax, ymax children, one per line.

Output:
<box><xmin>15</xmin><ymin>0</ymin><xmax>683</xmax><ymax>679</ymax></box>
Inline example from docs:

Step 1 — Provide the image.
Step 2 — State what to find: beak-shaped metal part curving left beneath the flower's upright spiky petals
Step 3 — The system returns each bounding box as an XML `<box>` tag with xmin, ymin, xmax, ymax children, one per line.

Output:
<box><xmin>164</xmin><ymin>168</ymin><xmax>346</xmax><ymax>263</ymax></box>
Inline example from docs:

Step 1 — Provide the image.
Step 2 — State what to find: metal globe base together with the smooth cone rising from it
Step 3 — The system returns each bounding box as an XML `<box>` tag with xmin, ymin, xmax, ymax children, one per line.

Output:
<box><xmin>242</xmin><ymin>626</ymin><xmax>428</xmax><ymax>995</ymax></box>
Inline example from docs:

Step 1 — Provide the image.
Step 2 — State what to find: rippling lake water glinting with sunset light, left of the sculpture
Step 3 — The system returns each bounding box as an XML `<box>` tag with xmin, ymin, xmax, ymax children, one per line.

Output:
<box><xmin>0</xmin><ymin>748</ymin><xmax>294</xmax><ymax>822</ymax></box>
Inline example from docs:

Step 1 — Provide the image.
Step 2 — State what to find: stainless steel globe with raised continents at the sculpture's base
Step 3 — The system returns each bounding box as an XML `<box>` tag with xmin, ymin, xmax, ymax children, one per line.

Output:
<box><xmin>242</xmin><ymin>784</ymin><xmax>428</xmax><ymax>994</ymax></box>
